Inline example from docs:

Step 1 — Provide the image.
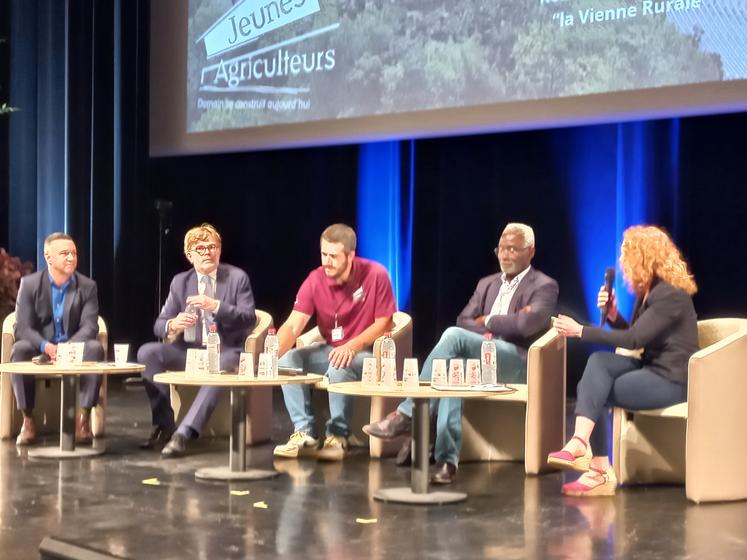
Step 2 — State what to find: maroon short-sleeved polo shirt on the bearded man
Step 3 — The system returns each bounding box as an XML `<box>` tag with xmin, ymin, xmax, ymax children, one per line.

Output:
<box><xmin>293</xmin><ymin>257</ymin><xmax>397</xmax><ymax>347</ymax></box>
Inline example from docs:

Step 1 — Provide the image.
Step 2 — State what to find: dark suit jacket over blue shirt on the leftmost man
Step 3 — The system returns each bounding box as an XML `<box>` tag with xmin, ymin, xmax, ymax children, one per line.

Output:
<box><xmin>16</xmin><ymin>268</ymin><xmax>99</xmax><ymax>349</ymax></box>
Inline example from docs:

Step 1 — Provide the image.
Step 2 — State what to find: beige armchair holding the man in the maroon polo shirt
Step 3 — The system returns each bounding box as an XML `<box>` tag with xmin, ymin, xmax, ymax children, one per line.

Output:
<box><xmin>296</xmin><ymin>311</ymin><xmax>412</xmax><ymax>457</ymax></box>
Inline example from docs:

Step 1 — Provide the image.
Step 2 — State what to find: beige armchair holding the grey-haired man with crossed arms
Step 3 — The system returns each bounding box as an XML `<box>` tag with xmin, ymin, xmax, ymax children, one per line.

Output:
<box><xmin>460</xmin><ymin>329</ymin><xmax>566</xmax><ymax>474</ymax></box>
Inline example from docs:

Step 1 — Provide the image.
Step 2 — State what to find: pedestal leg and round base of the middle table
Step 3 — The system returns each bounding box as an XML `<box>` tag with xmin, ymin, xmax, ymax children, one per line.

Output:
<box><xmin>195</xmin><ymin>387</ymin><xmax>279</xmax><ymax>481</ymax></box>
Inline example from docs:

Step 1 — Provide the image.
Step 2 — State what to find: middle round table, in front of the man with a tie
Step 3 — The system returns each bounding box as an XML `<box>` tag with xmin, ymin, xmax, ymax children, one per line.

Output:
<box><xmin>153</xmin><ymin>371</ymin><xmax>323</xmax><ymax>480</ymax></box>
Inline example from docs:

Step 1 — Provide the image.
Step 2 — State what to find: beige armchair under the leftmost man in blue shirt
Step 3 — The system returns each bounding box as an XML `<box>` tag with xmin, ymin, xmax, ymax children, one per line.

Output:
<box><xmin>0</xmin><ymin>313</ymin><xmax>109</xmax><ymax>438</ymax></box>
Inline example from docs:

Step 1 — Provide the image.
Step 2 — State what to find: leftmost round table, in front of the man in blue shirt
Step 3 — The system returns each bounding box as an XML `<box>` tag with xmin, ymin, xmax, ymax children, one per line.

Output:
<box><xmin>0</xmin><ymin>362</ymin><xmax>145</xmax><ymax>459</ymax></box>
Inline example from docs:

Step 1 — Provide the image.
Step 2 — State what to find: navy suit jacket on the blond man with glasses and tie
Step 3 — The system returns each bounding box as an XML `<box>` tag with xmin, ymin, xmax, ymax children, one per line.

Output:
<box><xmin>153</xmin><ymin>264</ymin><xmax>257</xmax><ymax>349</ymax></box>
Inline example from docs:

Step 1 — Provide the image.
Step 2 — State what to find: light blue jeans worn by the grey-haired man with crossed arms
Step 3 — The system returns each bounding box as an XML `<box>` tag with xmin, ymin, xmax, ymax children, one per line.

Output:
<box><xmin>397</xmin><ymin>327</ymin><xmax>527</xmax><ymax>465</ymax></box>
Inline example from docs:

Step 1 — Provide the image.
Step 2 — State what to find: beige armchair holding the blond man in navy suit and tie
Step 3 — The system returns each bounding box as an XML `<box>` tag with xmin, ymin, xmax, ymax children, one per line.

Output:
<box><xmin>170</xmin><ymin>309</ymin><xmax>272</xmax><ymax>445</ymax></box>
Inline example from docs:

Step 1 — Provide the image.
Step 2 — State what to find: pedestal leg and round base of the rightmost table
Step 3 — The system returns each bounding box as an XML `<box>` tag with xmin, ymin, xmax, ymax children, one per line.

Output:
<box><xmin>374</xmin><ymin>399</ymin><xmax>467</xmax><ymax>505</ymax></box>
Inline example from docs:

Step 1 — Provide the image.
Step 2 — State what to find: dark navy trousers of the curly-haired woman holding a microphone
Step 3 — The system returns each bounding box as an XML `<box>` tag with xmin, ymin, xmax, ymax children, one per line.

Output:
<box><xmin>576</xmin><ymin>352</ymin><xmax>687</xmax><ymax>457</ymax></box>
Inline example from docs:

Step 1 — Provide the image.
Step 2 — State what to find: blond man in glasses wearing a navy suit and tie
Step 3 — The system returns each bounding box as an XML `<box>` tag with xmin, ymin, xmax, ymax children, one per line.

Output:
<box><xmin>137</xmin><ymin>224</ymin><xmax>256</xmax><ymax>457</ymax></box>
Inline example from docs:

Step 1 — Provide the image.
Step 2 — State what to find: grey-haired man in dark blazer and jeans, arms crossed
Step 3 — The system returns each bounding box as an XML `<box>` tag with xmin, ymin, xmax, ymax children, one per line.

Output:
<box><xmin>363</xmin><ymin>224</ymin><xmax>558</xmax><ymax>484</ymax></box>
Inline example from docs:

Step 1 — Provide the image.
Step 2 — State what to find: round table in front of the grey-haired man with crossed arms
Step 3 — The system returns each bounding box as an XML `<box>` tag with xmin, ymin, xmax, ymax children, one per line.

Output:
<box><xmin>327</xmin><ymin>381</ymin><xmax>514</xmax><ymax>504</ymax></box>
